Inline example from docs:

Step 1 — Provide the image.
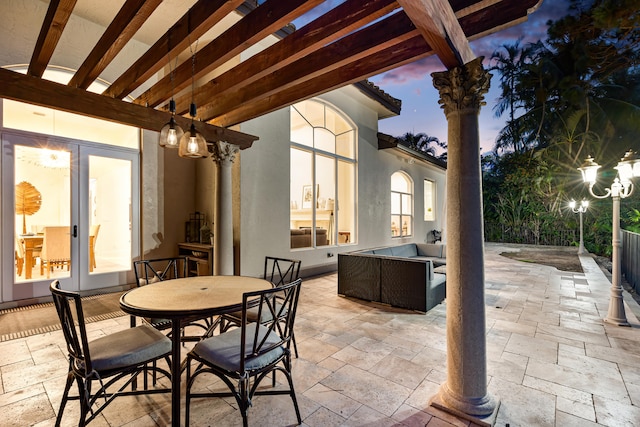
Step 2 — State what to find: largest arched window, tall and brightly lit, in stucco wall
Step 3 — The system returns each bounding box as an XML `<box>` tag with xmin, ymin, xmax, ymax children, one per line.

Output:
<box><xmin>289</xmin><ymin>100</ymin><xmax>357</xmax><ymax>248</ymax></box>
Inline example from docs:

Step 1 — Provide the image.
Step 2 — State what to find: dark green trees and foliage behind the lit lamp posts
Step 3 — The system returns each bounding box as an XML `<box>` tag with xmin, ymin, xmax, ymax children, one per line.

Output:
<box><xmin>483</xmin><ymin>0</ymin><xmax>640</xmax><ymax>252</ymax></box>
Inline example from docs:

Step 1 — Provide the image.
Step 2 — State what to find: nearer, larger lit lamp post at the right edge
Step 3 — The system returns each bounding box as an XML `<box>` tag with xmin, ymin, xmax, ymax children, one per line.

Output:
<box><xmin>578</xmin><ymin>150</ymin><xmax>640</xmax><ymax>326</ymax></box>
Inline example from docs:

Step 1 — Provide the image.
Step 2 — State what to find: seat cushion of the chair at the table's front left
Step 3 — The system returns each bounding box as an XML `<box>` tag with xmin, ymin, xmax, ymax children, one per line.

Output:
<box><xmin>89</xmin><ymin>325</ymin><xmax>171</xmax><ymax>372</ymax></box>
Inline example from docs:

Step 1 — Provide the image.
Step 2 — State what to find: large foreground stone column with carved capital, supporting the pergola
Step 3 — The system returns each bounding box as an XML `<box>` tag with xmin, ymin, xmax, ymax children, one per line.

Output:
<box><xmin>431</xmin><ymin>57</ymin><xmax>499</xmax><ymax>425</ymax></box>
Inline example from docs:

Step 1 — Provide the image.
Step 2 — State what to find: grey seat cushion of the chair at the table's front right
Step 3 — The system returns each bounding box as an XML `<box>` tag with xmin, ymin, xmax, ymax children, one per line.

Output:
<box><xmin>191</xmin><ymin>323</ymin><xmax>284</xmax><ymax>372</ymax></box>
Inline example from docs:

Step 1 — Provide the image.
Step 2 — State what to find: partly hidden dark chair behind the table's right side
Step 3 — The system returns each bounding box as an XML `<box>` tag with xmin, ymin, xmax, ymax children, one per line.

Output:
<box><xmin>220</xmin><ymin>256</ymin><xmax>302</xmax><ymax>358</ymax></box>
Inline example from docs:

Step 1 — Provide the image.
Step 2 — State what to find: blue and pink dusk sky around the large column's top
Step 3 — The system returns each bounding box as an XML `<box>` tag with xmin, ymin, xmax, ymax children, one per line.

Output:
<box><xmin>362</xmin><ymin>0</ymin><xmax>568</xmax><ymax>152</ymax></box>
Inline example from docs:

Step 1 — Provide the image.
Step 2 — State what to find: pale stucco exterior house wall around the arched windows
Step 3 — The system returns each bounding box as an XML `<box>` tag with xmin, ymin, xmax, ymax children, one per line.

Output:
<box><xmin>239</xmin><ymin>86</ymin><xmax>445</xmax><ymax>276</ymax></box>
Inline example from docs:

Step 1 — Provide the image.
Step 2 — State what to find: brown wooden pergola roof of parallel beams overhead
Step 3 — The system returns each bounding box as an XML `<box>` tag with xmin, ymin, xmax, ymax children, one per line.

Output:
<box><xmin>0</xmin><ymin>0</ymin><xmax>542</xmax><ymax>147</ymax></box>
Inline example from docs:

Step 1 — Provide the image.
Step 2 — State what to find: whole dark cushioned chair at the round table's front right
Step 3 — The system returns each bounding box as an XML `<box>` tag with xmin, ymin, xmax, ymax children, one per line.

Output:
<box><xmin>185</xmin><ymin>279</ymin><xmax>302</xmax><ymax>427</ymax></box>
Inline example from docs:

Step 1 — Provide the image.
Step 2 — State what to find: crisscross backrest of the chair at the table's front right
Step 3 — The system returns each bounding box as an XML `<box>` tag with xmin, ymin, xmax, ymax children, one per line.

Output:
<box><xmin>240</xmin><ymin>279</ymin><xmax>302</xmax><ymax>372</ymax></box>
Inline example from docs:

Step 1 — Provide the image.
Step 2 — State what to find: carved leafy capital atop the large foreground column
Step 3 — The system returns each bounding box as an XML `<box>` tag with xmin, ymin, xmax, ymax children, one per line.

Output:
<box><xmin>431</xmin><ymin>56</ymin><xmax>491</xmax><ymax>115</ymax></box>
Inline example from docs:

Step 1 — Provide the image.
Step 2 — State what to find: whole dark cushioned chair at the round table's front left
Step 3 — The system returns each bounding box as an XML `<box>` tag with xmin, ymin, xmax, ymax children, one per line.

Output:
<box><xmin>49</xmin><ymin>280</ymin><xmax>171</xmax><ymax>426</ymax></box>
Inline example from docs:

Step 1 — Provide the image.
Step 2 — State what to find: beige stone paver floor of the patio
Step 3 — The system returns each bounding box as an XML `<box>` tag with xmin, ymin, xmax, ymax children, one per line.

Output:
<box><xmin>0</xmin><ymin>244</ymin><xmax>640</xmax><ymax>427</ymax></box>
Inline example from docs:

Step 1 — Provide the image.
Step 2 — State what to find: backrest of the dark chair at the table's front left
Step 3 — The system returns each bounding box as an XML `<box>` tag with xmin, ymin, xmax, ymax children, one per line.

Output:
<box><xmin>49</xmin><ymin>280</ymin><xmax>93</xmax><ymax>373</ymax></box>
